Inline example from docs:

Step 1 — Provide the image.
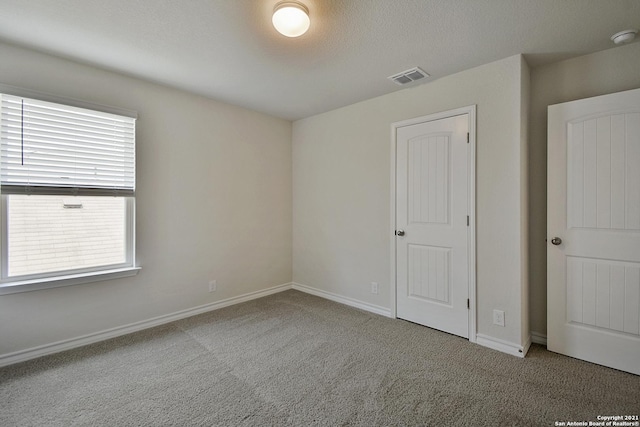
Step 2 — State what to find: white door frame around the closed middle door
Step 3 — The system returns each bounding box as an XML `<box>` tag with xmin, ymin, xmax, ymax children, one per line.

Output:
<box><xmin>389</xmin><ymin>105</ymin><xmax>476</xmax><ymax>342</ymax></box>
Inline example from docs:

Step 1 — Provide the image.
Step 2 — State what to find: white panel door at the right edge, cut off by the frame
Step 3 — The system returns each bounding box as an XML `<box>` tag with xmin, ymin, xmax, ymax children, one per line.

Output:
<box><xmin>547</xmin><ymin>89</ymin><xmax>640</xmax><ymax>374</ymax></box>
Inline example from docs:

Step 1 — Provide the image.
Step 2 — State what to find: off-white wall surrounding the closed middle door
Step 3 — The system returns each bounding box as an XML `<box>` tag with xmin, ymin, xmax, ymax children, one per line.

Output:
<box><xmin>293</xmin><ymin>55</ymin><xmax>528</xmax><ymax>346</ymax></box>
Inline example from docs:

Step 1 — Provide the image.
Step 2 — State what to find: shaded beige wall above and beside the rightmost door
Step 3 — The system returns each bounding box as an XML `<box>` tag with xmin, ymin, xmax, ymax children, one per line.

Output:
<box><xmin>529</xmin><ymin>43</ymin><xmax>640</xmax><ymax>335</ymax></box>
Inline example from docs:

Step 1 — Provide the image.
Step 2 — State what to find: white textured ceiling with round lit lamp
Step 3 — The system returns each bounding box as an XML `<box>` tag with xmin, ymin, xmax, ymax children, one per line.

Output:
<box><xmin>0</xmin><ymin>0</ymin><xmax>640</xmax><ymax>120</ymax></box>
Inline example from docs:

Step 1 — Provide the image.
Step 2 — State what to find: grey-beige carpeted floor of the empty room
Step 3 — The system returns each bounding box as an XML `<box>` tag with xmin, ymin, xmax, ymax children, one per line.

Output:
<box><xmin>0</xmin><ymin>291</ymin><xmax>640</xmax><ymax>426</ymax></box>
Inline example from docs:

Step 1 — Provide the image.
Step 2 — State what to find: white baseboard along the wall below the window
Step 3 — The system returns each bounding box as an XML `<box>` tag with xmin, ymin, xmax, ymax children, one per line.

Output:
<box><xmin>0</xmin><ymin>283</ymin><xmax>292</xmax><ymax>367</ymax></box>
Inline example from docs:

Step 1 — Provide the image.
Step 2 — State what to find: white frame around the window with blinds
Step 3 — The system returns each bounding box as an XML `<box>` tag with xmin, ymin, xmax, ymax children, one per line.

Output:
<box><xmin>0</xmin><ymin>84</ymin><xmax>141</xmax><ymax>295</ymax></box>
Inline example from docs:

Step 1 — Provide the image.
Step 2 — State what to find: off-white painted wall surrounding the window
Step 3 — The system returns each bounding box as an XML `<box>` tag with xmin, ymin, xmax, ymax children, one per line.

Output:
<box><xmin>0</xmin><ymin>44</ymin><xmax>292</xmax><ymax>355</ymax></box>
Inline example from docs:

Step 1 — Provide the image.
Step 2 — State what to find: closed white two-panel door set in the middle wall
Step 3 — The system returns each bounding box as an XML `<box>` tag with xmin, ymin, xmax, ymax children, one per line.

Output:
<box><xmin>396</xmin><ymin>114</ymin><xmax>469</xmax><ymax>338</ymax></box>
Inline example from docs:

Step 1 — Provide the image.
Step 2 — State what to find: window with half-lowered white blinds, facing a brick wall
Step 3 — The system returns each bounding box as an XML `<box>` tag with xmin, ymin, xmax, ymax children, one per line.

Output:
<box><xmin>0</xmin><ymin>94</ymin><xmax>138</xmax><ymax>293</ymax></box>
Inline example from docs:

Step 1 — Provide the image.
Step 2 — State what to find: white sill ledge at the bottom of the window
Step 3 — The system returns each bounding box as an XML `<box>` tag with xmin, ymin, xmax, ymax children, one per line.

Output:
<box><xmin>0</xmin><ymin>267</ymin><xmax>141</xmax><ymax>295</ymax></box>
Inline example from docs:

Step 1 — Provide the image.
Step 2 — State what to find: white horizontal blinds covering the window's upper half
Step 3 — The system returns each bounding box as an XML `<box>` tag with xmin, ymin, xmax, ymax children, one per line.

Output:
<box><xmin>0</xmin><ymin>94</ymin><xmax>135</xmax><ymax>196</ymax></box>
